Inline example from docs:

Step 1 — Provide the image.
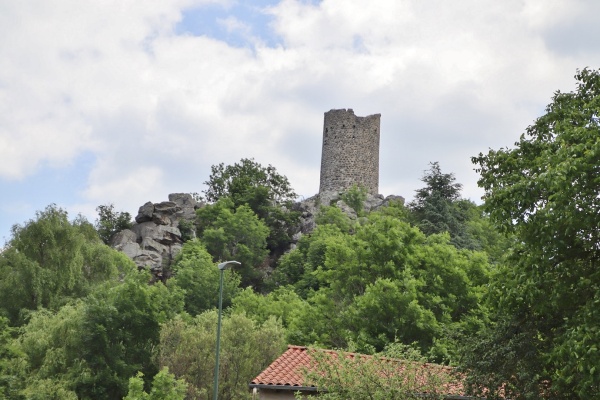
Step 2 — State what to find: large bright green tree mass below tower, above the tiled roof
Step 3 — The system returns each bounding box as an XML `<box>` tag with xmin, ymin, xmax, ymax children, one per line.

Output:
<box><xmin>279</xmin><ymin>212</ymin><xmax>489</xmax><ymax>361</ymax></box>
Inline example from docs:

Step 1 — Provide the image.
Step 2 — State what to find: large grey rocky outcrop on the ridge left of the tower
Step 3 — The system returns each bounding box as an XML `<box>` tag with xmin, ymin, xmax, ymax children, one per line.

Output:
<box><xmin>111</xmin><ymin>193</ymin><xmax>203</xmax><ymax>279</ymax></box>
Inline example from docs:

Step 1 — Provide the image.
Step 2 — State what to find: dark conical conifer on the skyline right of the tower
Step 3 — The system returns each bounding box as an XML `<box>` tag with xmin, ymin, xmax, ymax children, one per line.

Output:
<box><xmin>408</xmin><ymin>161</ymin><xmax>477</xmax><ymax>249</ymax></box>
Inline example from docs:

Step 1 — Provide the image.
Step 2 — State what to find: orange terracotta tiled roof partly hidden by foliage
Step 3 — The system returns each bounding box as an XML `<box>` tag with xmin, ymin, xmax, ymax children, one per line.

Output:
<box><xmin>250</xmin><ymin>345</ymin><xmax>468</xmax><ymax>399</ymax></box>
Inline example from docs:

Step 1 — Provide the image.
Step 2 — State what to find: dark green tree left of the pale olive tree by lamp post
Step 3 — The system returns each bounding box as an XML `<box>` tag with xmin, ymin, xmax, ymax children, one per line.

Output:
<box><xmin>77</xmin><ymin>273</ymin><xmax>183</xmax><ymax>399</ymax></box>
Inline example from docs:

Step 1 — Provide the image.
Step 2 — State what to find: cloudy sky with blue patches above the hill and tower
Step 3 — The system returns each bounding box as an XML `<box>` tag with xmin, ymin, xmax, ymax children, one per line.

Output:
<box><xmin>0</xmin><ymin>0</ymin><xmax>600</xmax><ymax>247</ymax></box>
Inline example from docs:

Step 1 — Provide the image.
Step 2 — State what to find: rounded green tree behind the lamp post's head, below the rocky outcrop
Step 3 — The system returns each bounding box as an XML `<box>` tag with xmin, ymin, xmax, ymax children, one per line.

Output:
<box><xmin>168</xmin><ymin>239</ymin><xmax>240</xmax><ymax>316</ymax></box>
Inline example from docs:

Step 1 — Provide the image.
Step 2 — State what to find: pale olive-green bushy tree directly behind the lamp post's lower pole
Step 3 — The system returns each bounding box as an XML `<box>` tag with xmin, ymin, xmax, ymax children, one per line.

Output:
<box><xmin>157</xmin><ymin>311</ymin><xmax>285</xmax><ymax>400</ymax></box>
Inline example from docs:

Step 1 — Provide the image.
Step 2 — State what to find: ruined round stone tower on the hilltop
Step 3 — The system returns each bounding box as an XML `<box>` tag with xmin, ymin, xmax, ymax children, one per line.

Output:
<box><xmin>319</xmin><ymin>108</ymin><xmax>381</xmax><ymax>195</ymax></box>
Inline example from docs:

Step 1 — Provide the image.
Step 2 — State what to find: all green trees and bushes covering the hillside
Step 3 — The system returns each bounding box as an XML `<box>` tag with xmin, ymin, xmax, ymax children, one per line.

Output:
<box><xmin>0</xmin><ymin>70</ymin><xmax>600</xmax><ymax>400</ymax></box>
